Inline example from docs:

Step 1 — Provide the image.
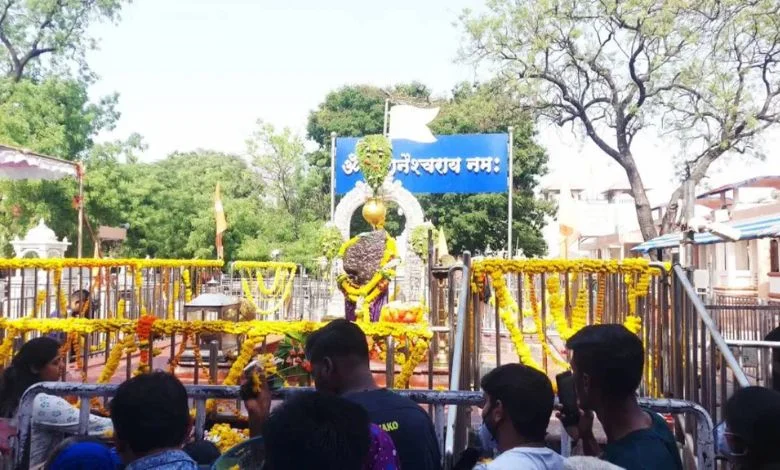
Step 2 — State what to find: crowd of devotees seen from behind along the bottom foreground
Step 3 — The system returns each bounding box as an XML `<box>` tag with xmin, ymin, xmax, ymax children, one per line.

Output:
<box><xmin>0</xmin><ymin>320</ymin><xmax>780</xmax><ymax>470</ymax></box>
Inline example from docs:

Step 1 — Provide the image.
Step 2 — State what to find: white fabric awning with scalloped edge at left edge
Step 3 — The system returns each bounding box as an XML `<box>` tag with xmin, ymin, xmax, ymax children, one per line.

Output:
<box><xmin>0</xmin><ymin>145</ymin><xmax>79</xmax><ymax>180</ymax></box>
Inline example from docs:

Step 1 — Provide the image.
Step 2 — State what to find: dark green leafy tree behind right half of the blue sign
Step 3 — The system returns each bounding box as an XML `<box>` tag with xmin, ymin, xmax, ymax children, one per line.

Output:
<box><xmin>430</xmin><ymin>82</ymin><xmax>551</xmax><ymax>256</ymax></box>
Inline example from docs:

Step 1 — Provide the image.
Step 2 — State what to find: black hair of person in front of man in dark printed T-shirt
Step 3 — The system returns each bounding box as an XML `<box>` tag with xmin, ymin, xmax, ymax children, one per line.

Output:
<box><xmin>263</xmin><ymin>392</ymin><xmax>371</xmax><ymax>470</ymax></box>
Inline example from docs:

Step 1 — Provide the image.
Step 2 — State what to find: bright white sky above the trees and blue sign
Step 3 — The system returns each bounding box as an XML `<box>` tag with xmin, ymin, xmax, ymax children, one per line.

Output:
<box><xmin>88</xmin><ymin>0</ymin><xmax>780</xmax><ymax>192</ymax></box>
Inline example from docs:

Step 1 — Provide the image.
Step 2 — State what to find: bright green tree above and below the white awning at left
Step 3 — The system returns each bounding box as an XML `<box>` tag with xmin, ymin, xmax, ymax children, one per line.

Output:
<box><xmin>0</xmin><ymin>78</ymin><xmax>117</xmax><ymax>255</ymax></box>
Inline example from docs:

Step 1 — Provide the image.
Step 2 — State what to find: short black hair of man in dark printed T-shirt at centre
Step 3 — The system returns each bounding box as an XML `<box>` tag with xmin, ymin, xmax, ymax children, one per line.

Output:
<box><xmin>306</xmin><ymin>320</ymin><xmax>368</xmax><ymax>363</ymax></box>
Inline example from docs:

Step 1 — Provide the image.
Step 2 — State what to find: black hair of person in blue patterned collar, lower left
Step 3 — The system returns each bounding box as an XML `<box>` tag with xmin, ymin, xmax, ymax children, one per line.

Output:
<box><xmin>111</xmin><ymin>372</ymin><xmax>190</xmax><ymax>454</ymax></box>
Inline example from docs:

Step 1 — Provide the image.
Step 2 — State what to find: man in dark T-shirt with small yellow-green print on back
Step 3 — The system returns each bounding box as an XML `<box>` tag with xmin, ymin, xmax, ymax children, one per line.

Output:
<box><xmin>306</xmin><ymin>320</ymin><xmax>441</xmax><ymax>470</ymax></box>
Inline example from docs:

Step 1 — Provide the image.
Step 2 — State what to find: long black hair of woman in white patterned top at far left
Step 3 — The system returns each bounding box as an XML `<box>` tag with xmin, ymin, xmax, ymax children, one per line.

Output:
<box><xmin>0</xmin><ymin>336</ymin><xmax>60</xmax><ymax>418</ymax></box>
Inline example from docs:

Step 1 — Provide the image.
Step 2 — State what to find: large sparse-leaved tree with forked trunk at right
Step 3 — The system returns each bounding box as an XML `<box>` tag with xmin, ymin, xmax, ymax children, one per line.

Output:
<box><xmin>463</xmin><ymin>0</ymin><xmax>780</xmax><ymax>240</ymax></box>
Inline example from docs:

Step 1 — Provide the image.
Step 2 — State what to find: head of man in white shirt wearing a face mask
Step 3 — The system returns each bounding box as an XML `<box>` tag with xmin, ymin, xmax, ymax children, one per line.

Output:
<box><xmin>481</xmin><ymin>364</ymin><xmax>555</xmax><ymax>452</ymax></box>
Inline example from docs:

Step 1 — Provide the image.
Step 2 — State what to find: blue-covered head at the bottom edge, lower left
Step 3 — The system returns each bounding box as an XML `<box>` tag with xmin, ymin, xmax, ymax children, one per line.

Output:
<box><xmin>43</xmin><ymin>437</ymin><xmax>120</xmax><ymax>470</ymax></box>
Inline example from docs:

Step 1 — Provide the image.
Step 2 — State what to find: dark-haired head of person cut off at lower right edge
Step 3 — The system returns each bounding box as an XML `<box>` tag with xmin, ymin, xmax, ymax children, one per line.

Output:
<box><xmin>716</xmin><ymin>387</ymin><xmax>780</xmax><ymax>468</ymax></box>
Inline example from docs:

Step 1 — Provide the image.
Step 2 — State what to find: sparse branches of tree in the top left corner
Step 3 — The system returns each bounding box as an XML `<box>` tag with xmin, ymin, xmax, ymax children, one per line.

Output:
<box><xmin>0</xmin><ymin>0</ymin><xmax>123</xmax><ymax>82</ymax></box>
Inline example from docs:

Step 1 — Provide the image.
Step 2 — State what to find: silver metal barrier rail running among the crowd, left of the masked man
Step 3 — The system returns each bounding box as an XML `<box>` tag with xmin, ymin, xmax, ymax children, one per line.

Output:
<box><xmin>13</xmin><ymin>382</ymin><xmax>484</xmax><ymax>470</ymax></box>
